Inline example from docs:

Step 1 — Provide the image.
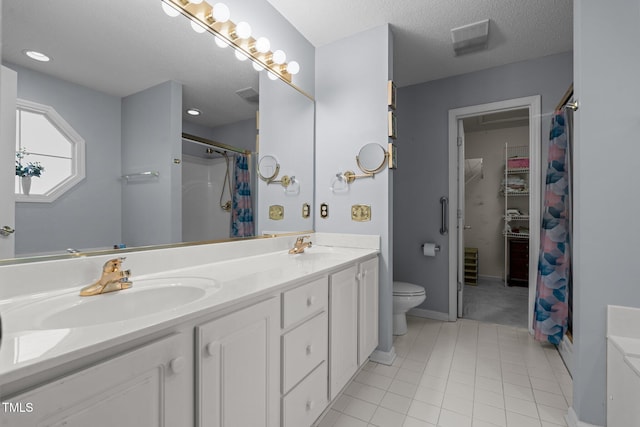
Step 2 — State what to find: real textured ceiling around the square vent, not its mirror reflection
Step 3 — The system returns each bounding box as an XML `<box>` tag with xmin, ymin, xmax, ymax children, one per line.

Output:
<box><xmin>268</xmin><ymin>0</ymin><xmax>573</xmax><ymax>86</ymax></box>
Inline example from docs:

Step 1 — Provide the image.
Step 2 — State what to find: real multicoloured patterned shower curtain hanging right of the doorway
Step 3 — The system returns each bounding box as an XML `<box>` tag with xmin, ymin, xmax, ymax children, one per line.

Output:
<box><xmin>533</xmin><ymin>109</ymin><xmax>571</xmax><ymax>344</ymax></box>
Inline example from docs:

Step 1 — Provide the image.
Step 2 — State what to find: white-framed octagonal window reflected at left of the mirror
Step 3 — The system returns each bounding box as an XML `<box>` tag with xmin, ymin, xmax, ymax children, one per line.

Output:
<box><xmin>15</xmin><ymin>99</ymin><xmax>85</xmax><ymax>202</ymax></box>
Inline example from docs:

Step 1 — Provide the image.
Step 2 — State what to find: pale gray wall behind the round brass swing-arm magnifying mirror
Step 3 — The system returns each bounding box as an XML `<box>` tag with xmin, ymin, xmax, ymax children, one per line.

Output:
<box><xmin>315</xmin><ymin>25</ymin><xmax>393</xmax><ymax>358</ymax></box>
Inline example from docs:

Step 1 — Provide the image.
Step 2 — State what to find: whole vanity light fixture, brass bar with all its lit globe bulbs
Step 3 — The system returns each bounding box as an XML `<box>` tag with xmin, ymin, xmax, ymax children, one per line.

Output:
<box><xmin>161</xmin><ymin>0</ymin><xmax>300</xmax><ymax>83</ymax></box>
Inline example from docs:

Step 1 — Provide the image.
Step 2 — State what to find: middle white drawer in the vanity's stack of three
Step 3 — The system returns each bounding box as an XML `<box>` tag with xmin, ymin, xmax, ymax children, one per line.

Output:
<box><xmin>282</xmin><ymin>311</ymin><xmax>329</xmax><ymax>393</ymax></box>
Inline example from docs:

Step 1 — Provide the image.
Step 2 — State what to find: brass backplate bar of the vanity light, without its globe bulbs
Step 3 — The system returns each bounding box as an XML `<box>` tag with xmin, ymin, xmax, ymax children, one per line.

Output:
<box><xmin>161</xmin><ymin>0</ymin><xmax>300</xmax><ymax>83</ymax></box>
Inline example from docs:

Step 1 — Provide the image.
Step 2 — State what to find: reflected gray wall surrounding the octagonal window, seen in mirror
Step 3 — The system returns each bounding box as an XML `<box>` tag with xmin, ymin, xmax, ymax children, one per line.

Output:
<box><xmin>6</xmin><ymin>64</ymin><xmax>122</xmax><ymax>256</ymax></box>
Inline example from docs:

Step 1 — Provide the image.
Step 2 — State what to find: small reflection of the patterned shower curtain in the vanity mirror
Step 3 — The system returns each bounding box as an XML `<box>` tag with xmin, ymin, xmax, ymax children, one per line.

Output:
<box><xmin>231</xmin><ymin>154</ymin><xmax>254</xmax><ymax>237</ymax></box>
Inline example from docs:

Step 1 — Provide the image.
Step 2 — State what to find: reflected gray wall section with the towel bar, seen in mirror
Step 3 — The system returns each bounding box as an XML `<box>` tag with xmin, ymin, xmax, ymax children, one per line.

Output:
<box><xmin>122</xmin><ymin>81</ymin><xmax>182</xmax><ymax>246</ymax></box>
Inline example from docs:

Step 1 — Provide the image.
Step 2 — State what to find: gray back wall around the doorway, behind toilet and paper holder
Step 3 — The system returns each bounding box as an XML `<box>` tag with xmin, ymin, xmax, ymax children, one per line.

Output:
<box><xmin>393</xmin><ymin>53</ymin><xmax>573</xmax><ymax>313</ymax></box>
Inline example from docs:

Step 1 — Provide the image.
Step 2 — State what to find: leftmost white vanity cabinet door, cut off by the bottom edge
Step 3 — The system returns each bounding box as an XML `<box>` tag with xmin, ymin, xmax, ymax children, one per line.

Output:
<box><xmin>1</xmin><ymin>334</ymin><xmax>193</xmax><ymax>427</ymax></box>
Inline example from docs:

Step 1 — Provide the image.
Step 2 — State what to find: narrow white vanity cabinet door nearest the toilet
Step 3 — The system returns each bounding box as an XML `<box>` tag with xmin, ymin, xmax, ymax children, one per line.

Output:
<box><xmin>358</xmin><ymin>258</ymin><xmax>378</xmax><ymax>365</ymax></box>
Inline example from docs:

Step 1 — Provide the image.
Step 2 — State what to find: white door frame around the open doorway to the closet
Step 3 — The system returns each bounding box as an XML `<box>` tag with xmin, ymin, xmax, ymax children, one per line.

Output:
<box><xmin>448</xmin><ymin>95</ymin><xmax>542</xmax><ymax>333</ymax></box>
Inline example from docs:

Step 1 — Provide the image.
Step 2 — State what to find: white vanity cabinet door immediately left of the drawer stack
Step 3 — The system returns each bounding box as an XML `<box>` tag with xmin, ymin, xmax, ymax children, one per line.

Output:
<box><xmin>196</xmin><ymin>298</ymin><xmax>280</xmax><ymax>427</ymax></box>
